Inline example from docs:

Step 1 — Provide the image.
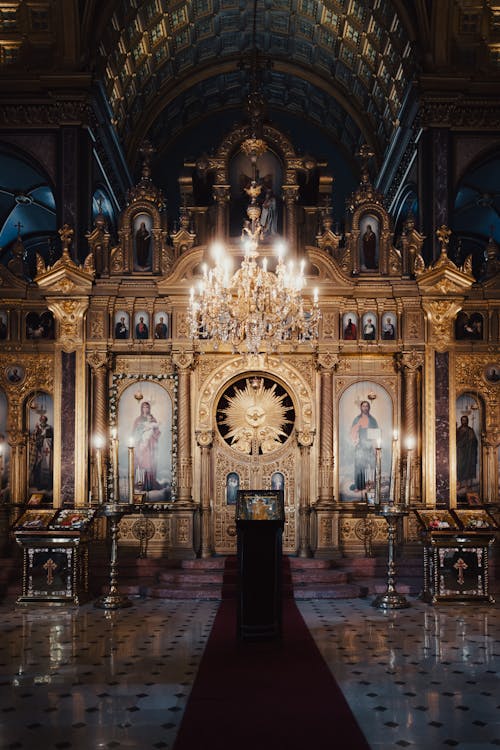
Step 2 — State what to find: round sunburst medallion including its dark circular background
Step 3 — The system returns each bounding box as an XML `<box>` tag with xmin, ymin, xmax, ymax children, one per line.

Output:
<box><xmin>217</xmin><ymin>376</ymin><xmax>295</xmax><ymax>454</ymax></box>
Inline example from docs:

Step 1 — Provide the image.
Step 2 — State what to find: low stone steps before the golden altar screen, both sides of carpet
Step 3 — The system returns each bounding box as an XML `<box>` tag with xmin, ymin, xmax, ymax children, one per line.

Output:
<box><xmin>0</xmin><ymin>547</ymin><xmax>500</xmax><ymax>601</ymax></box>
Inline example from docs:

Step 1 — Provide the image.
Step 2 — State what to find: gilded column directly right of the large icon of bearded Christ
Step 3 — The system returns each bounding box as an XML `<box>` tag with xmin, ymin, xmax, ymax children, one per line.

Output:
<box><xmin>401</xmin><ymin>352</ymin><xmax>424</xmax><ymax>500</ymax></box>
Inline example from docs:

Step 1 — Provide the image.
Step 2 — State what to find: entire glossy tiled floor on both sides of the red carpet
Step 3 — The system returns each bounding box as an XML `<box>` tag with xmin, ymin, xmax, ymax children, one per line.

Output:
<box><xmin>0</xmin><ymin>599</ymin><xmax>500</xmax><ymax>750</ymax></box>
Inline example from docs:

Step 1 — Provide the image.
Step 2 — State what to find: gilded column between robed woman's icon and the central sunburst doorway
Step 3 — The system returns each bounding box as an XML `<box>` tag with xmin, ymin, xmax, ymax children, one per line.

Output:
<box><xmin>173</xmin><ymin>352</ymin><xmax>193</xmax><ymax>505</ymax></box>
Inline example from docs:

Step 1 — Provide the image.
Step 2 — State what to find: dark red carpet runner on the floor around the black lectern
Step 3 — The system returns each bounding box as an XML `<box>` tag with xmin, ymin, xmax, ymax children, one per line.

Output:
<box><xmin>174</xmin><ymin>560</ymin><xmax>369</xmax><ymax>750</ymax></box>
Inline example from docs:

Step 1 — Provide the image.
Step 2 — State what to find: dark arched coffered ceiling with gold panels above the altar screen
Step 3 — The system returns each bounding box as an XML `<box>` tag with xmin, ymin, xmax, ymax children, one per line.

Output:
<box><xmin>96</xmin><ymin>0</ymin><xmax>419</xmax><ymax>165</ymax></box>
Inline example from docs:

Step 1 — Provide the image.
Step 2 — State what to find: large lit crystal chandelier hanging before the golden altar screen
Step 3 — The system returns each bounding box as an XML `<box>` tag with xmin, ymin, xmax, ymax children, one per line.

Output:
<box><xmin>188</xmin><ymin>204</ymin><xmax>321</xmax><ymax>354</ymax></box>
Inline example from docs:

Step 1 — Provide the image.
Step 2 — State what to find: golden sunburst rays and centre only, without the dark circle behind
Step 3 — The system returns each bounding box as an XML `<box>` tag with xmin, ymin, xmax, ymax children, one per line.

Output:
<box><xmin>220</xmin><ymin>378</ymin><xmax>292</xmax><ymax>453</ymax></box>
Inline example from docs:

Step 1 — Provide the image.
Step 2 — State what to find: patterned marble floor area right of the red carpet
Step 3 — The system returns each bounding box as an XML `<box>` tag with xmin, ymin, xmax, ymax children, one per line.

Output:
<box><xmin>299</xmin><ymin>598</ymin><xmax>500</xmax><ymax>750</ymax></box>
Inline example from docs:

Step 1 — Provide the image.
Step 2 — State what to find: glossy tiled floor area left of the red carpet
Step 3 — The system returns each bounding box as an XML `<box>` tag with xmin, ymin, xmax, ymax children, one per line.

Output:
<box><xmin>0</xmin><ymin>600</ymin><xmax>217</xmax><ymax>750</ymax></box>
